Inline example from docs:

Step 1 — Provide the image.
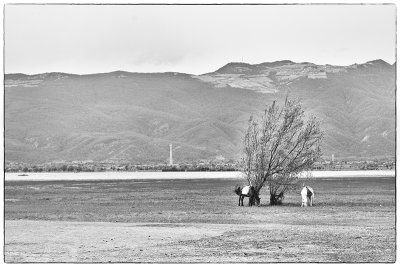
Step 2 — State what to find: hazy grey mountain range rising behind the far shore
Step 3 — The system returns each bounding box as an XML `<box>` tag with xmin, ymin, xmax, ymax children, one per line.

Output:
<box><xmin>5</xmin><ymin>60</ymin><xmax>395</xmax><ymax>163</ymax></box>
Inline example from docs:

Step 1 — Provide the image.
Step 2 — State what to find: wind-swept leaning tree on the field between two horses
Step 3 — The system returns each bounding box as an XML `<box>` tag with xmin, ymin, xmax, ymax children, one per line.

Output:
<box><xmin>241</xmin><ymin>97</ymin><xmax>323</xmax><ymax>205</ymax></box>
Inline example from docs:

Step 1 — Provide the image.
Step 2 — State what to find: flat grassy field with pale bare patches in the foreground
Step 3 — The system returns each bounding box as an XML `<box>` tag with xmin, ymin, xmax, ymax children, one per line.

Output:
<box><xmin>5</xmin><ymin>177</ymin><xmax>396</xmax><ymax>262</ymax></box>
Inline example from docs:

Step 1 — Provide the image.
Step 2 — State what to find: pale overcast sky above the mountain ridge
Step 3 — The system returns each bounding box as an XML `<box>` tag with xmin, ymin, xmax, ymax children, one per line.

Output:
<box><xmin>5</xmin><ymin>5</ymin><xmax>396</xmax><ymax>74</ymax></box>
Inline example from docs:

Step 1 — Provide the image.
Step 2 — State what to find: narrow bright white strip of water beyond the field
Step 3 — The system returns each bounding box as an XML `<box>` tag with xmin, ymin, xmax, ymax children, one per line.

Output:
<box><xmin>5</xmin><ymin>170</ymin><xmax>395</xmax><ymax>181</ymax></box>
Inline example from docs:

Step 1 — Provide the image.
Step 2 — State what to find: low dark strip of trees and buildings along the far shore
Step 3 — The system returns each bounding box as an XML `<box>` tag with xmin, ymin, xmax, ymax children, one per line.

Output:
<box><xmin>5</xmin><ymin>158</ymin><xmax>395</xmax><ymax>173</ymax></box>
